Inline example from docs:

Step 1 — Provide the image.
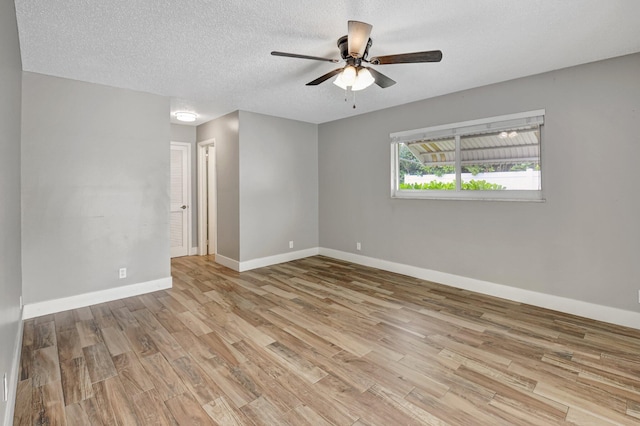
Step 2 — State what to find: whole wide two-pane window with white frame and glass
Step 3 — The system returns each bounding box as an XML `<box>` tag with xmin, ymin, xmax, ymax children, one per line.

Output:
<box><xmin>391</xmin><ymin>110</ymin><xmax>545</xmax><ymax>200</ymax></box>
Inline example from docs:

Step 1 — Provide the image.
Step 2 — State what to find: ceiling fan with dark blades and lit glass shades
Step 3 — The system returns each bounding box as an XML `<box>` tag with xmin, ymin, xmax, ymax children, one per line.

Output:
<box><xmin>271</xmin><ymin>21</ymin><xmax>442</xmax><ymax>91</ymax></box>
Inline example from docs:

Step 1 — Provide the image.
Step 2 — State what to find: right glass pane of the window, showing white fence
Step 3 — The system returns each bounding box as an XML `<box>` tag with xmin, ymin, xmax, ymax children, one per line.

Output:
<box><xmin>460</xmin><ymin>126</ymin><xmax>541</xmax><ymax>191</ymax></box>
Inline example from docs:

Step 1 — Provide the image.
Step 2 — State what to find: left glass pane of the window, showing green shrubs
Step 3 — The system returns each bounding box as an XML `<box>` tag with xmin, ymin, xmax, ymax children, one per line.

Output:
<box><xmin>397</xmin><ymin>139</ymin><xmax>456</xmax><ymax>191</ymax></box>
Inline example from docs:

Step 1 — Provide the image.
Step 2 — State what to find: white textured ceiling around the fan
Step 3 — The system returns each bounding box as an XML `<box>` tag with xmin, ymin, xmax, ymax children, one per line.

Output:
<box><xmin>15</xmin><ymin>0</ymin><xmax>640</xmax><ymax>124</ymax></box>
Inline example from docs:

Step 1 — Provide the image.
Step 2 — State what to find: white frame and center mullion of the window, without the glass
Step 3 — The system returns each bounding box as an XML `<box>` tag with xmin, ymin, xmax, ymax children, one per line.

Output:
<box><xmin>389</xmin><ymin>109</ymin><xmax>545</xmax><ymax>201</ymax></box>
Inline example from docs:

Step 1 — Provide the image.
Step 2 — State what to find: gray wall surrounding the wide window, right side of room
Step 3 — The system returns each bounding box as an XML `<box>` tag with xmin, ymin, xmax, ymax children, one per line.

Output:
<box><xmin>318</xmin><ymin>54</ymin><xmax>640</xmax><ymax>311</ymax></box>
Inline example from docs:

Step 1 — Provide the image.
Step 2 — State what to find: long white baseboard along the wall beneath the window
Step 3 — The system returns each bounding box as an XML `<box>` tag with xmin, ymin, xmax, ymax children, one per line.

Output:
<box><xmin>320</xmin><ymin>248</ymin><xmax>640</xmax><ymax>329</ymax></box>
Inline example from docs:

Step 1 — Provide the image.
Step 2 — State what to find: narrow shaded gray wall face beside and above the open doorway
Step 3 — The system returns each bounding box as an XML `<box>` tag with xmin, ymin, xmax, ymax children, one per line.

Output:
<box><xmin>197</xmin><ymin>111</ymin><xmax>240</xmax><ymax>260</ymax></box>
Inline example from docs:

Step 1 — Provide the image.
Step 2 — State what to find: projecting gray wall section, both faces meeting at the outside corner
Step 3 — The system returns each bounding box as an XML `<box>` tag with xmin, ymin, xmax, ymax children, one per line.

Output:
<box><xmin>197</xmin><ymin>111</ymin><xmax>318</xmax><ymax>261</ymax></box>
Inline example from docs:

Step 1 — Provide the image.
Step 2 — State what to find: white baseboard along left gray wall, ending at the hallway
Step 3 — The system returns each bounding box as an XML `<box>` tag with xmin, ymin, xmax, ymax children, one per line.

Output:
<box><xmin>22</xmin><ymin>277</ymin><xmax>173</xmax><ymax>319</ymax></box>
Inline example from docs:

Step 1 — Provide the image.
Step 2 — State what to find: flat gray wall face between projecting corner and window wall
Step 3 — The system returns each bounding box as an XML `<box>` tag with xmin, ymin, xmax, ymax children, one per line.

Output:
<box><xmin>240</xmin><ymin>111</ymin><xmax>318</xmax><ymax>261</ymax></box>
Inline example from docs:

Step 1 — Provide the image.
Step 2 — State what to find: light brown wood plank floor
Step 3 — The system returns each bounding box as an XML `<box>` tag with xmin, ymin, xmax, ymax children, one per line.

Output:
<box><xmin>14</xmin><ymin>256</ymin><xmax>640</xmax><ymax>425</ymax></box>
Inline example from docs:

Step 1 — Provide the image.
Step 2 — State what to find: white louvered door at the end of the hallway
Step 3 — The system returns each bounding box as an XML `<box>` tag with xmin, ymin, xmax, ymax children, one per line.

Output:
<box><xmin>170</xmin><ymin>142</ymin><xmax>191</xmax><ymax>257</ymax></box>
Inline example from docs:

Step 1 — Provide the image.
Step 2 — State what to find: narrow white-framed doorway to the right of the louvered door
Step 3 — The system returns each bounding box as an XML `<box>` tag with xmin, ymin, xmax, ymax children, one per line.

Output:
<box><xmin>198</xmin><ymin>139</ymin><xmax>218</xmax><ymax>256</ymax></box>
